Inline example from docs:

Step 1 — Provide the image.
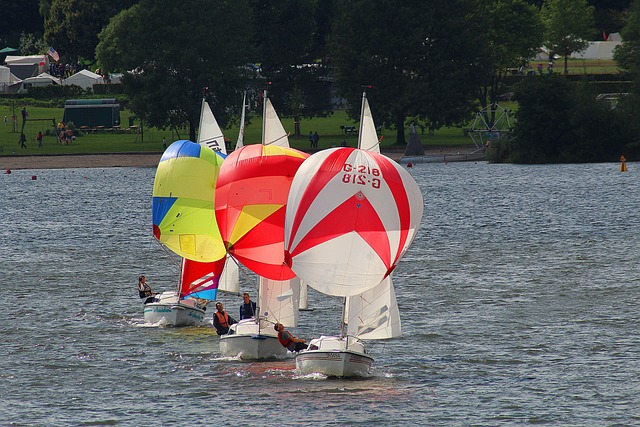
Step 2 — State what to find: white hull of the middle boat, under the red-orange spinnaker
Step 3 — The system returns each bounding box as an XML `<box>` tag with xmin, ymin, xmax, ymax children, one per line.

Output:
<box><xmin>220</xmin><ymin>319</ymin><xmax>287</xmax><ymax>360</ymax></box>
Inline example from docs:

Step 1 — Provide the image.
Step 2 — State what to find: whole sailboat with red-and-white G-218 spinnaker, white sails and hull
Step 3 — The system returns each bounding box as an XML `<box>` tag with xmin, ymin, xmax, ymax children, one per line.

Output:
<box><xmin>285</xmin><ymin>93</ymin><xmax>423</xmax><ymax>377</ymax></box>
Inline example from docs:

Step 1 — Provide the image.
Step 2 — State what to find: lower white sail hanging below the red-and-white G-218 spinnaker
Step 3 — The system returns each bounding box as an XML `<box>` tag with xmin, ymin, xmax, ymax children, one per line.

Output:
<box><xmin>345</xmin><ymin>277</ymin><xmax>402</xmax><ymax>339</ymax></box>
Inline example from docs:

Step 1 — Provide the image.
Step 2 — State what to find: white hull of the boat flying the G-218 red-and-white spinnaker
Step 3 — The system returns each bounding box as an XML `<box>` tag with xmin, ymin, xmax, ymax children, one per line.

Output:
<box><xmin>296</xmin><ymin>337</ymin><xmax>373</xmax><ymax>377</ymax></box>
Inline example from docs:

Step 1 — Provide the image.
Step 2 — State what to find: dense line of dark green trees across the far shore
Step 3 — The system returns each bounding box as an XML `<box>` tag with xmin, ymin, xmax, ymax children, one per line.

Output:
<box><xmin>0</xmin><ymin>0</ymin><xmax>640</xmax><ymax>161</ymax></box>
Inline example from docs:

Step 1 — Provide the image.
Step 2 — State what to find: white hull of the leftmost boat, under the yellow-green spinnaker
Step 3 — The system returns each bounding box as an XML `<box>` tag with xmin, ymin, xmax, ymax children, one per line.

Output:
<box><xmin>144</xmin><ymin>292</ymin><xmax>205</xmax><ymax>326</ymax></box>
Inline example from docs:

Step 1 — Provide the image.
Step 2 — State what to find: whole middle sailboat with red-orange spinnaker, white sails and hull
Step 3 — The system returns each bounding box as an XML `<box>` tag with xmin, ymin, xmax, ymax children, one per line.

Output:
<box><xmin>215</xmin><ymin>93</ymin><xmax>308</xmax><ymax>360</ymax></box>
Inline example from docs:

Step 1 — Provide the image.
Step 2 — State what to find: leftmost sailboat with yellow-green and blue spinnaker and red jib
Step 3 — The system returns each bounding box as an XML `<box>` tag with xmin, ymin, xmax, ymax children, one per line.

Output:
<box><xmin>149</xmin><ymin>140</ymin><xmax>226</xmax><ymax>326</ymax></box>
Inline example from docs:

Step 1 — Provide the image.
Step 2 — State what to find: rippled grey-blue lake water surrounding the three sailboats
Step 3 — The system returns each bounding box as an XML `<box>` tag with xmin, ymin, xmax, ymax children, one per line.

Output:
<box><xmin>0</xmin><ymin>162</ymin><xmax>640</xmax><ymax>427</ymax></box>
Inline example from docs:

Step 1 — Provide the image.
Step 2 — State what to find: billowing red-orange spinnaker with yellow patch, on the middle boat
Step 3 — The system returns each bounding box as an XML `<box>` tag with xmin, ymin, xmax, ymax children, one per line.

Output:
<box><xmin>215</xmin><ymin>144</ymin><xmax>308</xmax><ymax>280</ymax></box>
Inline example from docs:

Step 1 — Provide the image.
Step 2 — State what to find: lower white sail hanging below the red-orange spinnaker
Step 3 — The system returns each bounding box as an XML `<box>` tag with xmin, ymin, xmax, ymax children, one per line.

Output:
<box><xmin>258</xmin><ymin>277</ymin><xmax>300</xmax><ymax>328</ymax></box>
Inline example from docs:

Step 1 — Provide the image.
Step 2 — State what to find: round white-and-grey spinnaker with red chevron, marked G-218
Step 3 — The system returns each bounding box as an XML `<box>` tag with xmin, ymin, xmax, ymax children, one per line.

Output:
<box><xmin>284</xmin><ymin>147</ymin><xmax>424</xmax><ymax>296</ymax></box>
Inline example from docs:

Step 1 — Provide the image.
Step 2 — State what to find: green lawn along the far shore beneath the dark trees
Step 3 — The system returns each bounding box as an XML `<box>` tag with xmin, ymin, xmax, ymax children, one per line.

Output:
<box><xmin>0</xmin><ymin>105</ymin><xmax>472</xmax><ymax>156</ymax></box>
